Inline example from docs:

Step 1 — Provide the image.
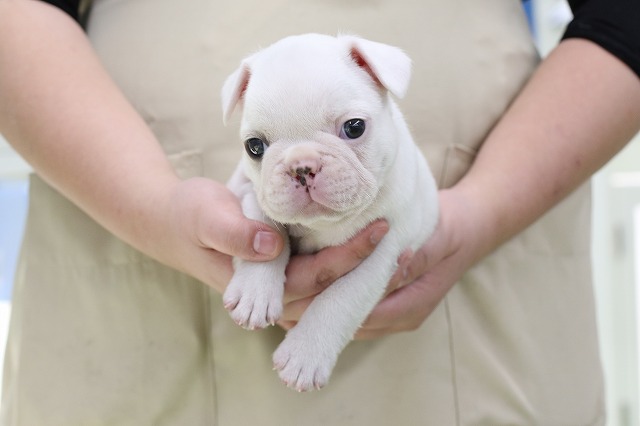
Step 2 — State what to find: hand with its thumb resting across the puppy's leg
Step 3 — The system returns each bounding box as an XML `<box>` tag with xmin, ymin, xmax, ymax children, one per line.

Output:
<box><xmin>148</xmin><ymin>178</ymin><xmax>284</xmax><ymax>293</ymax></box>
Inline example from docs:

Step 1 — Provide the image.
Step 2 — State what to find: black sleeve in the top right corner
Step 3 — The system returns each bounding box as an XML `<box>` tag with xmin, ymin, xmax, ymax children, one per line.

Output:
<box><xmin>562</xmin><ymin>0</ymin><xmax>640</xmax><ymax>77</ymax></box>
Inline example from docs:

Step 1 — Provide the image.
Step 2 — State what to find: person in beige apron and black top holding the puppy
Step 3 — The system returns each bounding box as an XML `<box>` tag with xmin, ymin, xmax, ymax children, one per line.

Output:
<box><xmin>0</xmin><ymin>0</ymin><xmax>640</xmax><ymax>425</ymax></box>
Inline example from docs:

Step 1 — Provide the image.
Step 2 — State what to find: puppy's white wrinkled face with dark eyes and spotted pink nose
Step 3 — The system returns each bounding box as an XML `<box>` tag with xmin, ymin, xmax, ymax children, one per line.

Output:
<box><xmin>241</xmin><ymin>45</ymin><xmax>396</xmax><ymax>228</ymax></box>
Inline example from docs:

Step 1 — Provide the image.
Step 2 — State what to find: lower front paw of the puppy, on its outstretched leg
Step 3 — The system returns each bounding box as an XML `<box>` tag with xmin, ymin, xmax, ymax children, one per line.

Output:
<box><xmin>273</xmin><ymin>330</ymin><xmax>337</xmax><ymax>392</ymax></box>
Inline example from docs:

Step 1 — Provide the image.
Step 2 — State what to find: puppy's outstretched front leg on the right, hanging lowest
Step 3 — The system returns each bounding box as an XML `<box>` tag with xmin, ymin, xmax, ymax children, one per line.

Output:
<box><xmin>273</xmin><ymin>235</ymin><xmax>400</xmax><ymax>392</ymax></box>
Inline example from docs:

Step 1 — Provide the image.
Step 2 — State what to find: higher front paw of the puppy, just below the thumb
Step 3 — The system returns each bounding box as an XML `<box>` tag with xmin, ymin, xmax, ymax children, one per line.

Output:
<box><xmin>222</xmin><ymin>268</ymin><xmax>284</xmax><ymax>330</ymax></box>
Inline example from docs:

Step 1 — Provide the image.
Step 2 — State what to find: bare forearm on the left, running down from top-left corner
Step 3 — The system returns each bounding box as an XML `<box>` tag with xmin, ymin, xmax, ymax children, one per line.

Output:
<box><xmin>0</xmin><ymin>0</ymin><xmax>178</xmax><ymax>256</ymax></box>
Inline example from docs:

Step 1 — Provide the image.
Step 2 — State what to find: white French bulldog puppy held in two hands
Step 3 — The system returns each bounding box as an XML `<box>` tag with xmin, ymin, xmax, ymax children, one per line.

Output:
<box><xmin>222</xmin><ymin>34</ymin><xmax>438</xmax><ymax>391</ymax></box>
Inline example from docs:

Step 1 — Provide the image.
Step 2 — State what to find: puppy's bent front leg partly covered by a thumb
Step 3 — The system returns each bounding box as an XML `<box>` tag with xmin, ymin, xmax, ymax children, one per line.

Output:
<box><xmin>223</xmin><ymin>186</ymin><xmax>290</xmax><ymax>330</ymax></box>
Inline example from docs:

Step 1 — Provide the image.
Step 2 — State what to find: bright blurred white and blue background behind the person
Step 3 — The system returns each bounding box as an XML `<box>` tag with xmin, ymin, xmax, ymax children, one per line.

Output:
<box><xmin>0</xmin><ymin>0</ymin><xmax>640</xmax><ymax>426</ymax></box>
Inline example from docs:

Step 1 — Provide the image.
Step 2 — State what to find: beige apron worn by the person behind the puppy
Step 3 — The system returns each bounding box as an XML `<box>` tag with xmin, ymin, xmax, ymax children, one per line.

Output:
<box><xmin>2</xmin><ymin>0</ymin><xmax>604</xmax><ymax>426</ymax></box>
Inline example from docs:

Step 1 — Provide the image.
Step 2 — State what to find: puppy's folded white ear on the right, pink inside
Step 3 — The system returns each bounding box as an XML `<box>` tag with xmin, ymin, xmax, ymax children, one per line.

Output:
<box><xmin>342</xmin><ymin>36</ymin><xmax>411</xmax><ymax>98</ymax></box>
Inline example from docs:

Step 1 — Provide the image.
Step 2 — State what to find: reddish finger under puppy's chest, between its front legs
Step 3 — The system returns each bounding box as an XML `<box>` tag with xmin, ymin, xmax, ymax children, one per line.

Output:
<box><xmin>285</xmin><ymin>220</ymin><xmax>389</xmax><ymax>303</ymax></box>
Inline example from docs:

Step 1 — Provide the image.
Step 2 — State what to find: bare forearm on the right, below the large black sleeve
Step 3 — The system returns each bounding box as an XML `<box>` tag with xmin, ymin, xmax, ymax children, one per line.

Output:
<box><xmin>452</xmin><ymin>39</ymin><xmax>640</xmax><ymax>261</ymax></box>
